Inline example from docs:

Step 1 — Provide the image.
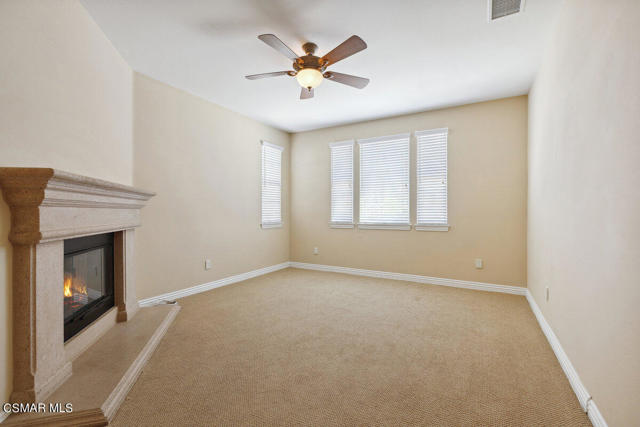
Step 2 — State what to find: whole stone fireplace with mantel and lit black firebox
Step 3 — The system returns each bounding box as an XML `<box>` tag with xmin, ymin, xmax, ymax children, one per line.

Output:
<box><xmin>0</xmin><ymin>168</ymin><xmax>153</xmax><ymax>407</ymax></box>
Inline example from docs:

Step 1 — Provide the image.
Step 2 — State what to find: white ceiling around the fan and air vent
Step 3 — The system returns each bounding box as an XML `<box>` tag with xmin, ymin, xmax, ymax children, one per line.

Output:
<box><xmin>82</xmin><ymin>0</ymin><xmax>561</xmax><ymax>132</ymax></box>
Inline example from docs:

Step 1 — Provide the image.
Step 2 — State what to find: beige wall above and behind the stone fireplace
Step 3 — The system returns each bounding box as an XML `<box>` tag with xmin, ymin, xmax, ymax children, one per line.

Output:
<box><xmin>0</xmin><ymin>0</ymin><xmax>133</xmax><ymax>408</ymax></box>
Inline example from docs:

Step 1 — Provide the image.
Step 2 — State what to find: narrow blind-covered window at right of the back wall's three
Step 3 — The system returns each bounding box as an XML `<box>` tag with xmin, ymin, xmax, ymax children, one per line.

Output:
<box><xmin>416</xmin><ymin>128</ymin><xmax>449</xmax><ymax>231</ymax></box>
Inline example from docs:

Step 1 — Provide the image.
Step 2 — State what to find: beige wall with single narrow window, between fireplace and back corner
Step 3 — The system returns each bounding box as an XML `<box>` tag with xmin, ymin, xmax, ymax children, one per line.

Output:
<box><xmin>134</xmin><ymin>74</ymin><xmax>290</xmax><ymax>298</ymax></box>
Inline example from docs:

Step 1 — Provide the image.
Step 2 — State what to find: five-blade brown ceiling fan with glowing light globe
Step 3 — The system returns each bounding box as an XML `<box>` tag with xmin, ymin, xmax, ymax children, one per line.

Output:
<box><xmin>245</xmin><ymin>34</ymin><xmax>369</xmax><ymax>99</ymax></box>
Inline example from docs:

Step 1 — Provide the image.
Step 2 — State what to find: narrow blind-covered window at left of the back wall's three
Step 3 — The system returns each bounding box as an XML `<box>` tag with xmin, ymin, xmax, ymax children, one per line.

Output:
<box><xmin>329</xmin><ymin>141</ymin><xmax>353</xmax><ymax>228</ymax></box>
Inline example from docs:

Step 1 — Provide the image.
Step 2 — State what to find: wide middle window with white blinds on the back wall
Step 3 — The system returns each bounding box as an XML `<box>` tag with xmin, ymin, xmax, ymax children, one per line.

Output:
<box><xmin>358</xmin><ymin>133</ymin><xmax>410</xmax><ymax>230</ymax></box>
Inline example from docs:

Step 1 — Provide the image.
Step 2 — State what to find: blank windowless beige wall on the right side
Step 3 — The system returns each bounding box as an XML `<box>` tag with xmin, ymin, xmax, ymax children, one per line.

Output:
<box><xmin>528</xmin><ymin>0</ymin><xmax>640</xmax><ymax>426</ymax></box>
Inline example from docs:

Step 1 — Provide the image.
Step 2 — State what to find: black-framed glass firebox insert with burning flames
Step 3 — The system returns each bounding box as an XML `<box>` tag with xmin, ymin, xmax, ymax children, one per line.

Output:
<box><xmin>63</xmin><ymin>233</ymin><xmax>114</xmax><ymax>342</ymax></box>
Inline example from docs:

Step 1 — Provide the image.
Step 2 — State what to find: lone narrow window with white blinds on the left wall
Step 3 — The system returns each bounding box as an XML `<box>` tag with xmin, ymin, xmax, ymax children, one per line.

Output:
<box><xmin>261</xmin><ymin>141</ymin><xmax>283</xmax><ymax>228</ymax></box>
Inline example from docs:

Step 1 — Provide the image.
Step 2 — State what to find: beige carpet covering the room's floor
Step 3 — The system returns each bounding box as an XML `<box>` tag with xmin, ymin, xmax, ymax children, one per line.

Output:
<box><xmin>112</xmin><ymin>269</ymin><xmax>590</xmax><ymax>426</ymax></box>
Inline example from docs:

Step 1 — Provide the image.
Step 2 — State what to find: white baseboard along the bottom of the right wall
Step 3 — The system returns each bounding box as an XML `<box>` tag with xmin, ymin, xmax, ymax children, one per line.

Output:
<box><xmin>526</xmin><ymin>289</ymin><xmax>607</xmax><ymax>427</ymax></box>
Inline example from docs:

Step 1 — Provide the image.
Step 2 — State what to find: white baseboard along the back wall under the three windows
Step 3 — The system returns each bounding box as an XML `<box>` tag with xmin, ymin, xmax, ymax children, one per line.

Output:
<box><xmin>289</xmin><ymin>261</ymin><xmax>527</xmax><ymax>295</ymax></box>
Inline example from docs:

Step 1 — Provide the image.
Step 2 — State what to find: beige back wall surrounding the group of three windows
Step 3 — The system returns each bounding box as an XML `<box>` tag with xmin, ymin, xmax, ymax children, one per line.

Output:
<box><xmin>291</xmin><ymin>96</ymin><xmax>527</xmax><ymax>286</ymax></box>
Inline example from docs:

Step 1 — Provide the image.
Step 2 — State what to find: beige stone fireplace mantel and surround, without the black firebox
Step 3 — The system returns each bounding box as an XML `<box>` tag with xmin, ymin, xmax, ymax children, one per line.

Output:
<box><xmin>0</xmin><ymin>168</ymin><xmax>154</xmax><ymax>402</ymax></box>
